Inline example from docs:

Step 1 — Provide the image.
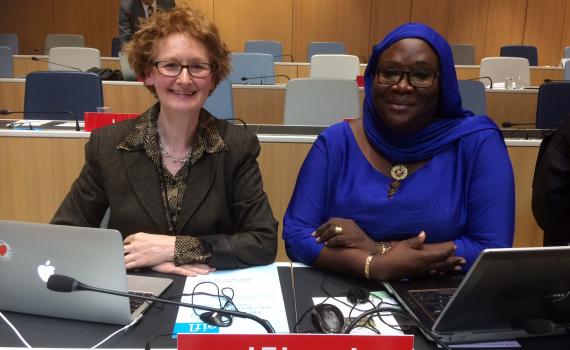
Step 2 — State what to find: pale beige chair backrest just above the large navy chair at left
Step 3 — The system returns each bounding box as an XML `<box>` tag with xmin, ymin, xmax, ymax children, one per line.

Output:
<box><xmin>48</xmin><ymin>47</ymin><xmax>101</xmax><ymax>72</ymax></box>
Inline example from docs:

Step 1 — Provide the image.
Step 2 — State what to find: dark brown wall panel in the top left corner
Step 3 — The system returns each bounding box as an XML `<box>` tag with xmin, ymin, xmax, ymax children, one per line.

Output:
<box><xmin>0</xmin><ymin>0</ymin><xmax>54</xmax><ymax>54</ymax></box>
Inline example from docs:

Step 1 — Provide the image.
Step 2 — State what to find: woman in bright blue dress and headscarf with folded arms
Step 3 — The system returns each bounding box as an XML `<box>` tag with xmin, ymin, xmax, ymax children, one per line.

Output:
<box><xmin>283</xmin><ymin>23</ymin><xmax>514</xmax><ymax>279</ymax></box>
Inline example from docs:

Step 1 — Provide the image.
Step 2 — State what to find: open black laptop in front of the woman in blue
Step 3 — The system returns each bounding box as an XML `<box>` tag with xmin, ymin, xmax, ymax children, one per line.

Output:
<box><xmin>383</xmin><ymin>246</ymin><xmax>570</xmax><ymax>343</ymax></box>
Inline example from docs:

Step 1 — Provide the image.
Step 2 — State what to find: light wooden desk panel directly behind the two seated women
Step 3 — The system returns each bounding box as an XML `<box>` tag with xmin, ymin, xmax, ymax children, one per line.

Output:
<box><xmin>0</xmin><ymin>132</ymin><xmax>542</xmax><ymax>261</ymax></box>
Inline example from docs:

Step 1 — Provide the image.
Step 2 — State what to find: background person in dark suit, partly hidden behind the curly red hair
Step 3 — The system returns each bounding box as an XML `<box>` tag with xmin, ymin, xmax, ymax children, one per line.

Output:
<box><xmin>119</xmin><ymin>0</ymin><xmax>176</xmax><ymax>45</ymax></box>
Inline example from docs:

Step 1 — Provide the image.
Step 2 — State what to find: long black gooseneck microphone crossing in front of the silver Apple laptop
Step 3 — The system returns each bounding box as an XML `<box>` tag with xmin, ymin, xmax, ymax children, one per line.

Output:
<box><xmin>46</xmin><ymin>275</ymin><xmax>275</xmax><ymax>333</ymax></box>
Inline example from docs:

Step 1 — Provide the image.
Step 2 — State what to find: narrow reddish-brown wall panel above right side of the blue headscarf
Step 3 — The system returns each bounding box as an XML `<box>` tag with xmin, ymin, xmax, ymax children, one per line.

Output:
<box><xmin>410</xmin><ymin>0</ymin><xmax>451</xmax><ymax>37</ymax></box>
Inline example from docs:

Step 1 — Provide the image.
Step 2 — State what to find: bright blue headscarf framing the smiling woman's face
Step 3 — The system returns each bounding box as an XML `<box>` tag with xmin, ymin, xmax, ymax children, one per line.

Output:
<box><xmin>364</xmin><ymin>23</ymin><xmax>498</xmax><ymax>164</ymax></box>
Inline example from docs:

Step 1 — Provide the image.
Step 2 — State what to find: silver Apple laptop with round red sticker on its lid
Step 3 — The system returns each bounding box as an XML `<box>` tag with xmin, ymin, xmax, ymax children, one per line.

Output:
<box><xmin>0</xmin><ymin>221</ymin><xmax>172</xmax><ymax>325</ymax></box>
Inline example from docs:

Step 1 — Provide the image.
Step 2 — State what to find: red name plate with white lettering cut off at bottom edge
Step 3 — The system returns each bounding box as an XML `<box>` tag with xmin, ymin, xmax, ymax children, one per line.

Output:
<box><xmin>178</xmin><ymin>334</ymin><xmax>414</xmax><ymax>350</ymax></box>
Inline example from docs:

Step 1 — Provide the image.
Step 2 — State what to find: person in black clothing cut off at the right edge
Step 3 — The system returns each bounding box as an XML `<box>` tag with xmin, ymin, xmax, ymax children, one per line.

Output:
<box><xmin>532</xmin><ymin>117</ymin><xmax>570</xmax><ymax>246</ymax></box>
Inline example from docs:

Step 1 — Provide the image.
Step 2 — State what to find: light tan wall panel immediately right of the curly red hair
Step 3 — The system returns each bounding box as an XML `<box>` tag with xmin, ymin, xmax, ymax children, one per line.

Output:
<box><xmin>214</xmin><ymin>0</ymin><xmax>292</xmax><ymax>54</ymax></box>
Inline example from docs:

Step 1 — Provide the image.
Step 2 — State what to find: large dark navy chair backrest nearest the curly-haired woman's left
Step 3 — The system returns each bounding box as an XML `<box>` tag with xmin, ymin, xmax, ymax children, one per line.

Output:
<box><xmin>24</xmin><ymin>71</ymin><xmax>105</xmax><ymax>120</ymax></box>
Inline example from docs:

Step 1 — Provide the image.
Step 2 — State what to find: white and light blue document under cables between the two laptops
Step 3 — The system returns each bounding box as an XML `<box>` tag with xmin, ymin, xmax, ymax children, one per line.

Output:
<box><xmin>172</xmin><ymin>264</ymin><xmax>289</xmax><ymax>334</ymax></box>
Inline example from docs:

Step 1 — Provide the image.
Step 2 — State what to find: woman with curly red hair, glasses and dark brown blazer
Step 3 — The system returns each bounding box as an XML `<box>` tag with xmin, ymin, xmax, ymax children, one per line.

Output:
<box><xmin>52</xmin><ymin>6</ymin><xmax>277</xmax><ymax>276</ymax></box>
